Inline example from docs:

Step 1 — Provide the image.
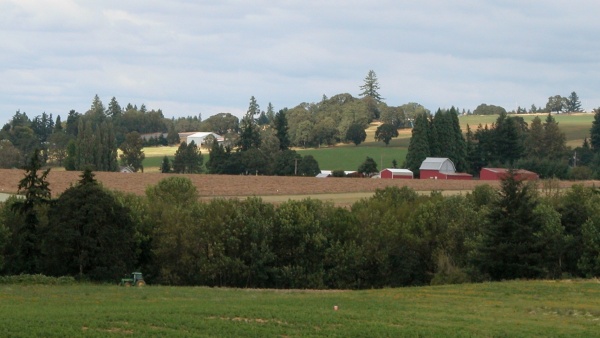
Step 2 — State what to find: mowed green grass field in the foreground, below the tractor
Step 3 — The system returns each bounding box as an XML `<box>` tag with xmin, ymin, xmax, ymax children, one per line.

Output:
<box><xmin>0</xmin><ymin>280</ymin><xmax>600</xmax><ymax>337</ymax></box>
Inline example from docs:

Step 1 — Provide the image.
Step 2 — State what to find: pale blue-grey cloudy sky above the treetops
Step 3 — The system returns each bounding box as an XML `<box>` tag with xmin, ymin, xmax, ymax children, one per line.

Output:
<box><xmin>0</xmin><ymin>0</ymin><xmax>600</xmax><ymax>124</ymax></box>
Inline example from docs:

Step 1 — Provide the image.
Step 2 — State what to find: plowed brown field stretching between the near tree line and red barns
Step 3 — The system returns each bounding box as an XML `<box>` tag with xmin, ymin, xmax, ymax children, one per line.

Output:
<box><xmin>0</xmin><ymin>169</ymin><xmax>600</xmax><ymax>197</ymax></box>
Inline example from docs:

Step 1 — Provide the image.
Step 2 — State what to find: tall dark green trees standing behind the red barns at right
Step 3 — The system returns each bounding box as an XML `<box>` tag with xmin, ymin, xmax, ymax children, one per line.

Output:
<box><xmin>404</xmin><ymin>108</ymin><xmax>600</xmax><ymax>179</ymax></box>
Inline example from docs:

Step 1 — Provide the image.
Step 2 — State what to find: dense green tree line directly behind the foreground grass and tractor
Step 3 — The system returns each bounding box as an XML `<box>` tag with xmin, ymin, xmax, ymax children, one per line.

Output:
<box><xmin>0</xmin><ymin>157</ymin><xmax>600</xmax><ymax>289</ymax></box>
